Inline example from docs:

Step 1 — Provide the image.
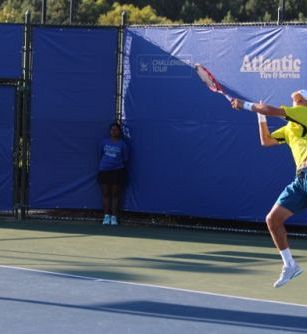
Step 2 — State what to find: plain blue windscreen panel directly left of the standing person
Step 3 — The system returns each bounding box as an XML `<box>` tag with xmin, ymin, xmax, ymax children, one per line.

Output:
<box><xmin>29</xmin><ymin>27</ymin><xmax>117</xmax><ymax>208</ymax></box>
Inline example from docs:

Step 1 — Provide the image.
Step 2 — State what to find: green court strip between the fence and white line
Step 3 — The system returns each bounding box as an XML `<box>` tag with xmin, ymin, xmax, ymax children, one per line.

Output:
<box><xmin>0</xmin><ymin>221</ymin><xmax>307</xmax><ymax>305</ymax></box>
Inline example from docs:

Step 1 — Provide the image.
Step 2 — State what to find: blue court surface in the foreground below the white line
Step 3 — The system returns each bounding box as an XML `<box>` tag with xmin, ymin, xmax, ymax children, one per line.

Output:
<box><xmin>0</xmin><ymin>266</ymin><xmax>307</xmax><ymax>334</ymax></box>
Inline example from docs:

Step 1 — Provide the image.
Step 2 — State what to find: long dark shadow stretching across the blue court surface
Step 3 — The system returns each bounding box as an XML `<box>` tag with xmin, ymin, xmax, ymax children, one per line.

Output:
<box><xmin>0</xmin><ymin>297</ymin><xmax>307</xmax><ymax>333</ymax></box>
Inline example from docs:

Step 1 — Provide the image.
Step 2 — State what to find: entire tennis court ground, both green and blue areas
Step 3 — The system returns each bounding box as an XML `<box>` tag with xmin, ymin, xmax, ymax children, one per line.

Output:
<box><xmin>0</xmin><ymin>222</ymin><xmax>307</xmax><ymax>334</ymax></box>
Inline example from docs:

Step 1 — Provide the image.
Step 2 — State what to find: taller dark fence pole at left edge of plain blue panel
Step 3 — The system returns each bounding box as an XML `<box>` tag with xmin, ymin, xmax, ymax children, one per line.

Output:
<box><xmin>18</xmin><ymin>11</ymin><xmax>31</xmax><ymax>220</ymax></box>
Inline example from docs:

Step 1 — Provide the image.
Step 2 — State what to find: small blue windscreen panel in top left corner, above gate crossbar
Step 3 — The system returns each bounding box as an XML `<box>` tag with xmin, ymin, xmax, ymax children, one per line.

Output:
<box><xmin>0</xmin><ymin>24</ymin><xmax>23</xmax><ymax>79</ymax></box>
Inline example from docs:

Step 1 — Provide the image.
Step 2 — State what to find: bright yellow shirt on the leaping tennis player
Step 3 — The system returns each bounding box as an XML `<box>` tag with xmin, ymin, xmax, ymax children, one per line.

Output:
<box><xmin>271</xmin><ymin>106</ymin><xmax>307</xmax><ymax>168</ymax></box>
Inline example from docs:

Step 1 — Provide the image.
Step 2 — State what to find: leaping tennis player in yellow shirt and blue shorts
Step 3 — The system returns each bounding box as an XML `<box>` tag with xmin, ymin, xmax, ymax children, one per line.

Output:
<box><xmin>231</xmin><ymin>89</ymin><xmax>307</xmax><ymax>288</ymax></box>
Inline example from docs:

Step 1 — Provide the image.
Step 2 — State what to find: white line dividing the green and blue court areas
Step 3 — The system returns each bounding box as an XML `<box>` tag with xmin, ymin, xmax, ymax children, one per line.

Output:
<box><xmin>0</xmin><ymin>265</ymin><xmax>307</xmax><ymax>309</ymax></box>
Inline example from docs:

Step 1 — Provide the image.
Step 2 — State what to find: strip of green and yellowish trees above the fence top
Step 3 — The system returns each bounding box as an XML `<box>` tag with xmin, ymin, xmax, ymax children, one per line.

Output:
<box><xmin>0</xmin><ymin>0</ymin><xmax>307</xmax><ymax>25</ymax></box>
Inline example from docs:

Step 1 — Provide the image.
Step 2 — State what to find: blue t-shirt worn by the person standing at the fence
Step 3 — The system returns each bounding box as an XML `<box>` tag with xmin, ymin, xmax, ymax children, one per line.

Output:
<box><xmin>99</xmin><ymin>138</ymin><xmax>129</xmax><ymax>171</ymax></box>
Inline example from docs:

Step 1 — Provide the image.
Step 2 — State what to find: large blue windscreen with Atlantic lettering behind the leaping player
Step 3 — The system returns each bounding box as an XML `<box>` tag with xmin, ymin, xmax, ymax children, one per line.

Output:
<box><xmin>123</xmin><ymin>26</ymin><xmax>307</xmax><ymax>223</ymax></box>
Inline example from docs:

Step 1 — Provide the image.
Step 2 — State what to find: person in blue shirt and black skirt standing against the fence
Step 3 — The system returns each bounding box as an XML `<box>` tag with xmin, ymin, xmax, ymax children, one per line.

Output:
<box><xmin>98</xmin><ymin>123</ymin><xmax>129</xmax><ymax>225</ymax></box>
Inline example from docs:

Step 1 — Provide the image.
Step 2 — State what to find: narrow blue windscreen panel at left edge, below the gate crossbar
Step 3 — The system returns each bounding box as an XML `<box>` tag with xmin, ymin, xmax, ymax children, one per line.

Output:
<box><xmin>0</xmin><ymin>86</ymin><xmax>15</xmax><ymax>210</ymax></box>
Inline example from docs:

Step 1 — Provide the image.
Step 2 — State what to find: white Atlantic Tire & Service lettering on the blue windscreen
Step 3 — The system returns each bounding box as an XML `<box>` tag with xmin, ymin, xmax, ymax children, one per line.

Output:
<box><xmin>240</xmin><ymin>54</ymin><xmax>302</xmax><ymax>79</ymax></box>
